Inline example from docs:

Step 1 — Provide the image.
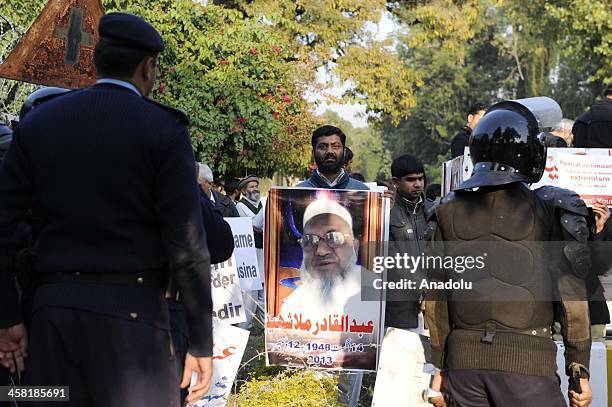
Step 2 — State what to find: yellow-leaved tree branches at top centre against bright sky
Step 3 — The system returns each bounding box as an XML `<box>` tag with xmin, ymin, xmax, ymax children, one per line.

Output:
<box><xmin>216</xmin><ymin>0</ymin><xmax>419</xmax><ymax>122</ymax></box>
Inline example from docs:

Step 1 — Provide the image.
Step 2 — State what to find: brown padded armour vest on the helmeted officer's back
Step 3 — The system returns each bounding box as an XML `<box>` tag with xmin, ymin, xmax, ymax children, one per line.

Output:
<box><xmin>436</xmin><ymin>183</ymin><xmax>559</xmax><ymax>336</ymax></box>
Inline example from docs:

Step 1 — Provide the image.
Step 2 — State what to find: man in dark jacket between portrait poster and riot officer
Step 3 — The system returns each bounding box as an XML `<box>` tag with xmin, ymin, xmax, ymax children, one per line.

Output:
<box><xmin>385</xmin><ymin>154</ymin><xmax>434</xmax><ymax>329</ymax></box>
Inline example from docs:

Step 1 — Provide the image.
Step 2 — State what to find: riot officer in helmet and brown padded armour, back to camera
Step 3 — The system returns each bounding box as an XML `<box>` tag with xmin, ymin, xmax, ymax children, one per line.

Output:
<box><xmin>425</xmin><ymin>98</ymin><xmax>592</xmax><ymax>407</ymax></box>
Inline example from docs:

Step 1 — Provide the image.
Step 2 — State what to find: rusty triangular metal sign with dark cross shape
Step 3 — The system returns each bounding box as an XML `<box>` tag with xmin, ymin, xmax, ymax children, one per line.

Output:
<box><xmin>0</xmin><ymin>0</ymin><xmax>104</xmax><ymax>89</ymax></box>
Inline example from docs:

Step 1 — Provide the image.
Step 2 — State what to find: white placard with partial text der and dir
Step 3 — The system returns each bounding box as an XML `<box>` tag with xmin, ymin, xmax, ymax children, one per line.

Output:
<box><xmin>210</xmin><ymin>255</ymin><xmax>246</xmax><ymax>324</ymax></box>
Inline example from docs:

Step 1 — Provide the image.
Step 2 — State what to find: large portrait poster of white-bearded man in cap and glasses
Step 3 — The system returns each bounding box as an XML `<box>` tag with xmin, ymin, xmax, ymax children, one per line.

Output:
<box><xmin>264</xmin><ymin>188</ymin><xmax>388</xmax><ymax>371</ymax></box>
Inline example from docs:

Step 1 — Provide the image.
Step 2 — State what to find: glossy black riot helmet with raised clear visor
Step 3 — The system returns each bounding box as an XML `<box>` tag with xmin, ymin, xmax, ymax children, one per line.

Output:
<box><xmin>468</xmin><ymin>97</ymin><xmax>562</xmax><ymax>187</ymax></box>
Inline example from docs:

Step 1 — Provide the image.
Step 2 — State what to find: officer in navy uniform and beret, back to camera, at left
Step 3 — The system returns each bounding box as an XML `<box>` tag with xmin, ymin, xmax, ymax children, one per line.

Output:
<box><xmin>0</xmin><ymin>13</ymin><xmax>212</xmax><ymax>406</ymax></box>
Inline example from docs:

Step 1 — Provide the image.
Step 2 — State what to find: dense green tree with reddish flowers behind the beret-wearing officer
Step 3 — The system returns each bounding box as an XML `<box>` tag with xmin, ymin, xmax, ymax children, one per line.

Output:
<box><xmin>0</xmin><ymin>0</ymin><xmax>315</xmax><ymax>178</ymax></box>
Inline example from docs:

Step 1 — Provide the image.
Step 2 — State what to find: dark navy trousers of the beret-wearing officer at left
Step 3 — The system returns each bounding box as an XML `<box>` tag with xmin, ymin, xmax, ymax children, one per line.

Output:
<box><xmin>25</xmin><ymin>307</ymin><xmax>180</xmax><ymax>407</ymax></box>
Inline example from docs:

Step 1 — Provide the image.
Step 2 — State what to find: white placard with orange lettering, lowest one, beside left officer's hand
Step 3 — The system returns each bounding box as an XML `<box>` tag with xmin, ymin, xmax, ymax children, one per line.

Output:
<box><xmin>191</xmin><ymin>319</ymin><xmax>249</xmax><ymax>407</ymax></box>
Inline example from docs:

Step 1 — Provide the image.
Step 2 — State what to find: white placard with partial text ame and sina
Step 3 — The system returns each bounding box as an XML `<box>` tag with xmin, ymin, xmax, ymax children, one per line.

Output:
<box><xmin>224</xmin><ymin>217</ymin><xmax>263</xmax><ymax>291</ymax></box>
